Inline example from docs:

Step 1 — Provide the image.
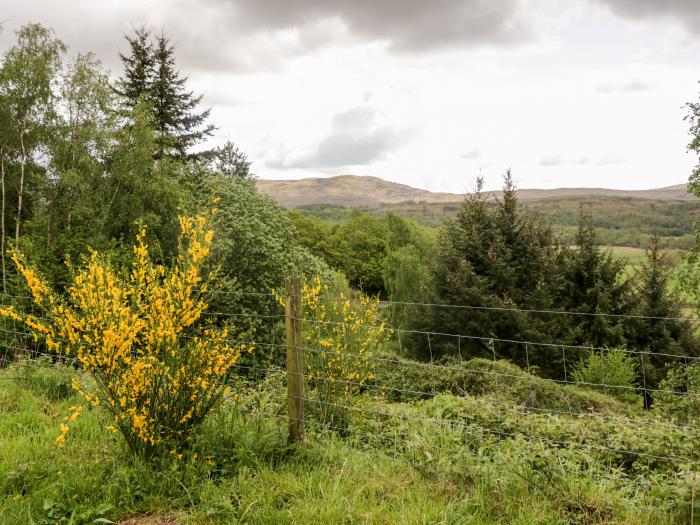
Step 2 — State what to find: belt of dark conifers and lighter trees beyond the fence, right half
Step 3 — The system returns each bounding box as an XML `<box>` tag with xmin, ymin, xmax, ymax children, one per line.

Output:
<box><xmin>292</xmin><ymin>171</ymin><xmax>700</xmax><ymax>398</ymax></box>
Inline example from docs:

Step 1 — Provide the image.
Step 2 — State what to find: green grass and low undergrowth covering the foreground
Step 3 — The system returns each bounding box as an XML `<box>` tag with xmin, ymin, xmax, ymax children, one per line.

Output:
<box><xmin>0</xmin><ymin>363</ymin><xmax>698</xmax><ymax>525</ymax></box>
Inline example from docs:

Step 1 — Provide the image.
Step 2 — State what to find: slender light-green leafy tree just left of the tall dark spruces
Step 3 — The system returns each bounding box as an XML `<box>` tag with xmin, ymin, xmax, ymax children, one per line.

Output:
<box><xmin>28</xmin><ymin>54</ymin><xmax>114</xmax><ymax>281</ymax></box>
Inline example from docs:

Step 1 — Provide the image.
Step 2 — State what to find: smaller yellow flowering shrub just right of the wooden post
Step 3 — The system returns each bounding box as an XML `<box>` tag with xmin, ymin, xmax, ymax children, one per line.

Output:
<box><xmin>301</xmin><ymin>277</ymin><xmax>387</xmax><ymax>430</ymax></box>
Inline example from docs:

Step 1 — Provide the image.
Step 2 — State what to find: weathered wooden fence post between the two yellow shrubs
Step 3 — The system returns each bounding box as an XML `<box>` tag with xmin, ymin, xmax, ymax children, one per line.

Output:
<box><xmin>284</xmin><ymin>277</ymin><xmax>304</xmax><ymax>443</ymax></box>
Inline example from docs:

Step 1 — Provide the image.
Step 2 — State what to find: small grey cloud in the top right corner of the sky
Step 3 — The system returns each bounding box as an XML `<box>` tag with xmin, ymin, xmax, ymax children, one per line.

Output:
<box><xmin>593</xmin><ymin>0</ymin><xmax>700</xmax><ymax>36</ymax></box>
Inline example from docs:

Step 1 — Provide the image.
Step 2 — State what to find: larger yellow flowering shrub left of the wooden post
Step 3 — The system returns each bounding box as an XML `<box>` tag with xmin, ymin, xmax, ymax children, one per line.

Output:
<box><xmin>0</xmin><ymin>211</ymin><xmax>252</xmax><ymax>456</ymax></box>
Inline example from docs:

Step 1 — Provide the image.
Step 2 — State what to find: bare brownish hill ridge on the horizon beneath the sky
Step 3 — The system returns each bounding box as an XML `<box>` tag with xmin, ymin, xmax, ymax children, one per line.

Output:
<box><xmin>257</xmin><ymin>175</ymin><xmax>696</xmax><ymax>208</ymax></box>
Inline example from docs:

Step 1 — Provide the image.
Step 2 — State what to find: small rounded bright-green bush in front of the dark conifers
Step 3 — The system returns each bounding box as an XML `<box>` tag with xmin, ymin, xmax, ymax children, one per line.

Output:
<box><xmin>571</xmin><ymin>349</ymin><xmax>642</xmax><ymax>404</ymax></box>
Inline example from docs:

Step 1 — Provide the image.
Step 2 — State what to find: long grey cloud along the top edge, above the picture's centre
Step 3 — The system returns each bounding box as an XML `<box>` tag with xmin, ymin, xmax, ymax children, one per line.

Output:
<box><xmin>207</xmin><ymin>0</ymin><xmax>531</xmax><ymax>52</ymax></box>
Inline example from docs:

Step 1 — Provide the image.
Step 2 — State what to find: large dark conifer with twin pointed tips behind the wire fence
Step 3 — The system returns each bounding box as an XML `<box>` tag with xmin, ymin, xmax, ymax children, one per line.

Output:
<box><xmin>415</xmin><ymin>171</ymin><xmax>563</xmax><ymax>376</ymax></box>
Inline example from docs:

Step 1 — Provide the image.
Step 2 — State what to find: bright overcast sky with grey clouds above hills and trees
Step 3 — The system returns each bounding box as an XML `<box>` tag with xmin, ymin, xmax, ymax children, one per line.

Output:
<box><xmin>0</xmin><ymin>0</ymin><xmax>700</xmax><ymax>193</ymax></box>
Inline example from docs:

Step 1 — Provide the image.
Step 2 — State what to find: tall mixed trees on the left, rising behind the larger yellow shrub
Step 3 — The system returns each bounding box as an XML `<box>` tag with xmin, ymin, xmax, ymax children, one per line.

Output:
<box><xmin>0</xmin><ymin>24</ymin><xmax>331</xmax><ymax>374</ymax></box>
